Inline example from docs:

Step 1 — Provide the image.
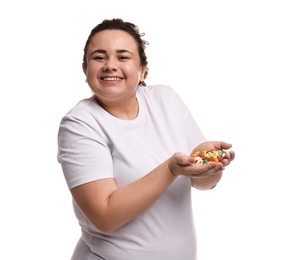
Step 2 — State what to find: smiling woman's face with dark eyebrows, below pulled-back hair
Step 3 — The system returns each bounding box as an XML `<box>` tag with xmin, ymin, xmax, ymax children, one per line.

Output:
<box><xmin>83</xmin><ymin>30</ymin><xmax>147</xmax><ymax>104</ymax></box>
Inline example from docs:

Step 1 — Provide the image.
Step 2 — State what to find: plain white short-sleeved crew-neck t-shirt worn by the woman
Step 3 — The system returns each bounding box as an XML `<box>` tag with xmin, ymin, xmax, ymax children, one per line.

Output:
<box><xmin>58</xmin><ymin>85</ymin><xmax>205</xmax><ymax>260</ymax></box>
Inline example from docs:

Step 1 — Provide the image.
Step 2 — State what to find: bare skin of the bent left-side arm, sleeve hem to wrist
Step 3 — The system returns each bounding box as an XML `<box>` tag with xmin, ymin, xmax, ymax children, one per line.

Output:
<box><xmin>72</xmin><ymin>158</ymin><xmax>176</xmax><ymax>233</ymax></box>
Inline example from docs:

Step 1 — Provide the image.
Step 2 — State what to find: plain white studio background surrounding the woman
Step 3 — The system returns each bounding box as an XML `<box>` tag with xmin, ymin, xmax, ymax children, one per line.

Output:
<box><xmin>0</xmin><ymin>0</ymin><xmax>287</xmax><ymax>260</ymax></box>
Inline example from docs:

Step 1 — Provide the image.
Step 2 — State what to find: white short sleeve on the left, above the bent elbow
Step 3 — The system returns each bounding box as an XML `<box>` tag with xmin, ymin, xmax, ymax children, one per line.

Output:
<box><xmin>58</xmin><ymin>116</ymin><xmax>113</xmax><ymax>189</ymax></box>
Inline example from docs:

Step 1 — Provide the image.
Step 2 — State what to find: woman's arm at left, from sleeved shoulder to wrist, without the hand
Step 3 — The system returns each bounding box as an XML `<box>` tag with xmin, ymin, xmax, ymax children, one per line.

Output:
<box><xmin>58</xmin><ymin>117</ymin><xmax>176</xmax><ymax>233</ymax></box>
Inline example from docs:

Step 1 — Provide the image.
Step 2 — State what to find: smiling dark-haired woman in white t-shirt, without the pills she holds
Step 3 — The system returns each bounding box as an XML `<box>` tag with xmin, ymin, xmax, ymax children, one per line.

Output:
<box><xmin>58</xmin><ymin>19</ymin><xmax>235</xmax><ymax>260</ymax></box>
